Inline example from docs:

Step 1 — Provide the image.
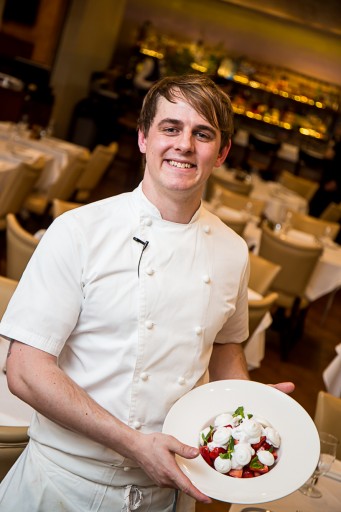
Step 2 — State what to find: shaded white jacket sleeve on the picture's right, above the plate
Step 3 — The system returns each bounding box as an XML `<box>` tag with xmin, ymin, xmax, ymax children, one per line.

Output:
<box><xmin>215</xmin><ymin>244</ymin><xmax>250</xmax><ymax>343</ymax></box>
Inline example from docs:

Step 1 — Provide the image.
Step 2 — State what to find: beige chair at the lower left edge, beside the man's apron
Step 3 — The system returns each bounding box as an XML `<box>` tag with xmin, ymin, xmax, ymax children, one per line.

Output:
<box><xmin>0</xmin><ymin>426</ymin><xmax>29</xmax><ymax>481</ymax></box>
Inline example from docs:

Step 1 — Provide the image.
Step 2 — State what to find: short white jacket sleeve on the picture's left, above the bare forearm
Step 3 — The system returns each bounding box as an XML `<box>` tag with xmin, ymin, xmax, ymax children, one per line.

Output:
<box><xmin>0</xmin><ymin>215</ymin><xmax>85</xmax><ymax>356</ymax></box>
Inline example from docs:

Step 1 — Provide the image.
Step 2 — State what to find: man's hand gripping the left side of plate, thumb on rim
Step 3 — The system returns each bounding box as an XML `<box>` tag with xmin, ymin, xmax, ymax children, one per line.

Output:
<box><xmin>134</xmin><ymin>433</ymin><xmax>212</xmax><ymax>503</ymax></box>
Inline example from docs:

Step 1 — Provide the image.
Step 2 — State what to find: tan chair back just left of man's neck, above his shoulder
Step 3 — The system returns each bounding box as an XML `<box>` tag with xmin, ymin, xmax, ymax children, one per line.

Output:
<box><xmin>75</xmin><ymin>142</ymin><xmax>118</xmax><ymax>201</ymax></box>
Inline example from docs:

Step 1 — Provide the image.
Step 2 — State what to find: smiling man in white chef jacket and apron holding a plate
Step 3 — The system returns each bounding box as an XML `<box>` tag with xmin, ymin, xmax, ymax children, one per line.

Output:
<box><xmin>0</xmin><ymin>75</ymin><xmax>290</xmax><ymax>512</ymax></box>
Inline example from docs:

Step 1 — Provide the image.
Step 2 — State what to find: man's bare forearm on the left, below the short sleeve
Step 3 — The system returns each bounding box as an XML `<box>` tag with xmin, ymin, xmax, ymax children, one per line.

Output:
<box><xmin>7</xmin><ymin>341</ymin><xmax>142</xmax><ymax>457</ymax></box>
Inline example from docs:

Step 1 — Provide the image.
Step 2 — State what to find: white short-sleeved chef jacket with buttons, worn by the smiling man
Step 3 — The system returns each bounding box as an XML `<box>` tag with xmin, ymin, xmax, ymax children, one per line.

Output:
<box><xmin>0</xmin><ymin>185</ymin><xmax>248</xmax><ymax>483</ymax></box>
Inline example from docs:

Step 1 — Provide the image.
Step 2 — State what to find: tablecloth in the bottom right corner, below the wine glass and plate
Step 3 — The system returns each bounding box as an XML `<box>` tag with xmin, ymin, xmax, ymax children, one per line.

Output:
<box><xmin>227</xmin><ymin>460</ymin><xmax>341</xmax><ymax>512</ymax></box>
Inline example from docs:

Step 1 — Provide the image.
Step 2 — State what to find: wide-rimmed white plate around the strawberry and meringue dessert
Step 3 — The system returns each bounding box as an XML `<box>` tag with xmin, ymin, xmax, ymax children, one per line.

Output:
<box><xmin>163</xmin><ymin>380</ymin><xmax>320</xmax><ymax>504</ymax></box>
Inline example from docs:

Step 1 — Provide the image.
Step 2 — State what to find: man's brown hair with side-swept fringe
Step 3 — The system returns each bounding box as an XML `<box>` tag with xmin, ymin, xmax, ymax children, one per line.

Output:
<box><xmin>138</xmin><ymin>74</ymin><xmax>233</xmax><ymax>149</ymax></box>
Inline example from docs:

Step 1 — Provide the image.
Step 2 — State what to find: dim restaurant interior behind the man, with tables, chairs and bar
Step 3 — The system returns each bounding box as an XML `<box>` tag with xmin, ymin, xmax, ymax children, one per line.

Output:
<box><xmin>0</xmin><ymin>0</ymin><xmax>341</xmax><ymax>512</ymax></box>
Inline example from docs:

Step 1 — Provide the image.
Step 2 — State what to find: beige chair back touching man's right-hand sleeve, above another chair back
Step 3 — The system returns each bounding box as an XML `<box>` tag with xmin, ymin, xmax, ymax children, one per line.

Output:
<box><xmin>249</xmin><ymin>252</ymin><xmax>281</xmax><ymax>296</ymax></box>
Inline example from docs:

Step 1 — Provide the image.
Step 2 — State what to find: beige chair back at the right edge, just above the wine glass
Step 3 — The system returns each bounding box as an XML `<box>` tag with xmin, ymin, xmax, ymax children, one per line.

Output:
<box><xmin>314</xmin><ymin>391</ymin><xmax>341</xmax><ymax>459</ymax></box>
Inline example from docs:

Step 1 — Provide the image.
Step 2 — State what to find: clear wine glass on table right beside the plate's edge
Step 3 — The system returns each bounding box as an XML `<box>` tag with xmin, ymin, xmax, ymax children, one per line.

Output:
<box><xmin>299</xmin><ymin>432</ymin><xmax>339</xmax><ymax>498</ymax></box>
